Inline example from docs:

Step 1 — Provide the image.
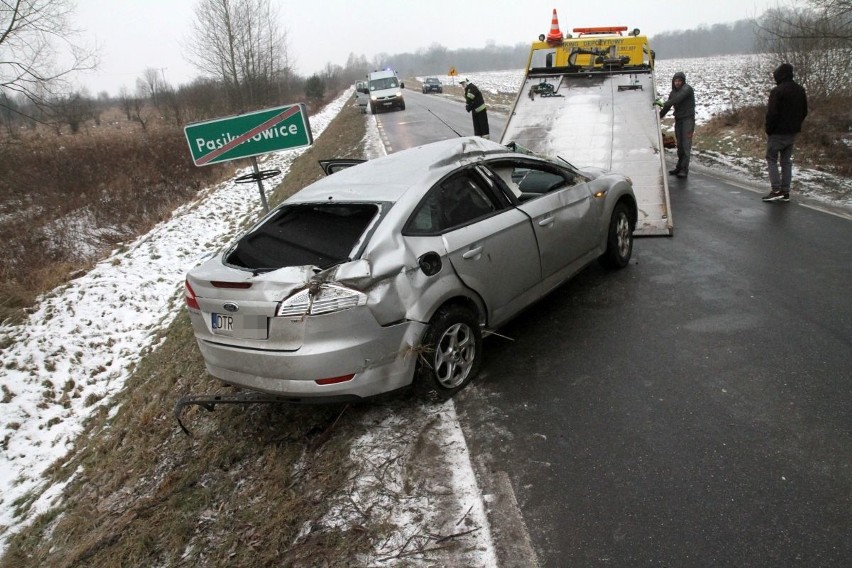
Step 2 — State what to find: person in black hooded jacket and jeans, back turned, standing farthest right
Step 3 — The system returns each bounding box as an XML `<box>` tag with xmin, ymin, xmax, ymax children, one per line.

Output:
<box><xmin>763</xmin><ymin>63</ymin><xmax>808</xmax><ymax>201</ymax></box>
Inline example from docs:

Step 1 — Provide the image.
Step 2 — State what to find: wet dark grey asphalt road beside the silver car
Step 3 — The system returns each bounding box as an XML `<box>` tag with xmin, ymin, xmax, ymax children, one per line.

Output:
<box><xmin>379</xmin><ymin>93</ymin><xmax>852</xmax><ymax>567</ymax></box>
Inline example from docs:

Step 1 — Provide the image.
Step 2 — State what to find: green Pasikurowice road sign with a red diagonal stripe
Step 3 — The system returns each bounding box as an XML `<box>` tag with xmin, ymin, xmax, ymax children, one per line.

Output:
<box><xmin>183</xmin><ymin>103</ymin><xmax>314</xmax><ymax>166</ymax></box>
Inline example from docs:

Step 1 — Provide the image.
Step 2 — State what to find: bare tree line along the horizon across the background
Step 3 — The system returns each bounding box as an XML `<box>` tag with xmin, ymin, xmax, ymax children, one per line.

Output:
<box><xmin>0</xmin><ymin>0</ymin><xmax>852</xmax><ymax>134</ymax></box>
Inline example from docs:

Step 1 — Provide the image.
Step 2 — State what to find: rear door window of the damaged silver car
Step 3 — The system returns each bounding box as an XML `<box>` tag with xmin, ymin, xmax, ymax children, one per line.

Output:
<box><xmin>404</xmin><ymin>172</ymin><xmax>499</xmax><ymax>234</ymax></box>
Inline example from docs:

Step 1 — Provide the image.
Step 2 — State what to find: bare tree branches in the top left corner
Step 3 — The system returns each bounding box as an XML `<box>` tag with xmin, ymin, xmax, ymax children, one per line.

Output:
<box><xmin>0</xmin><ymin>0</ymin><xmax>97</xmax><ymax>118</ymax></box>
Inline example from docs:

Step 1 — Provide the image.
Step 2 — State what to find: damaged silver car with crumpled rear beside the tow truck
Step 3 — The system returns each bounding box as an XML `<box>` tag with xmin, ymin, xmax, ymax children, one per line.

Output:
<box><xmin>185</xmin><ymin>137</ymin><xmax>637</xmax><ymax>401</ymax></box>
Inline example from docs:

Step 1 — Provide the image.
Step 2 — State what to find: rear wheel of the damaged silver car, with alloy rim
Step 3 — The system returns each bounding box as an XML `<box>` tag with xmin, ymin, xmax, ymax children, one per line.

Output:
<box><xmin>414</xmin><ymin>305</ymin><xmax>482</xmax><ymax>400</ymax></box>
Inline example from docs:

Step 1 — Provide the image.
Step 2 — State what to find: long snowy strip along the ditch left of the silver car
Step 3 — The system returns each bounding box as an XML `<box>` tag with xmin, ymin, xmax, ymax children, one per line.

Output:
<box><xmin>0</xmin><ymin>93</ymin><xmax>351</xmax><ymax>541</ymax></box>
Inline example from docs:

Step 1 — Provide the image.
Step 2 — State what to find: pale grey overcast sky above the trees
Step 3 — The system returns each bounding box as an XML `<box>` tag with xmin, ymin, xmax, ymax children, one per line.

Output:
<box><xmin>77</xmin><ymin>0</ymin><xmax>791</xmax><ymax>95</ymax></box>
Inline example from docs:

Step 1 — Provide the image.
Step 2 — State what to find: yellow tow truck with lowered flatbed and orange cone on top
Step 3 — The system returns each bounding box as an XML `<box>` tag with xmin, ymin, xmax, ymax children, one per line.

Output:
<box><xmin>501</xmin><ymin>10</ymin><xmax>673</xmax><ymax>236</ymax></box>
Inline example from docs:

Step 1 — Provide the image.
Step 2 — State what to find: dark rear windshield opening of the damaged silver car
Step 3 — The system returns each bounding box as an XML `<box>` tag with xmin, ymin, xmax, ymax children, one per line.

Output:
<box><xmin>225</xmin><ymin>203</ymin><xmax>379</xmax><ymax>271</ymax></box>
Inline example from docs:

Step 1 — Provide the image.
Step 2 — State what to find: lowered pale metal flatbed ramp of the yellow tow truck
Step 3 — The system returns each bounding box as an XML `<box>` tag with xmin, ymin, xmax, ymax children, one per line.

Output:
<box><xmin>502</xmin><ymin>73</ymin><xmax>672</xmax><ymax>236</ymax></box>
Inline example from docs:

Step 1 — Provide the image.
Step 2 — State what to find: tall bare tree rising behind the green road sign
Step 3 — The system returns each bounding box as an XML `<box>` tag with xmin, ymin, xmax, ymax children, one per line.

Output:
<box><xmin>187</xmin><ymin>0</ymin><xmax>291</xmax><ymax>110</ymax></box>
